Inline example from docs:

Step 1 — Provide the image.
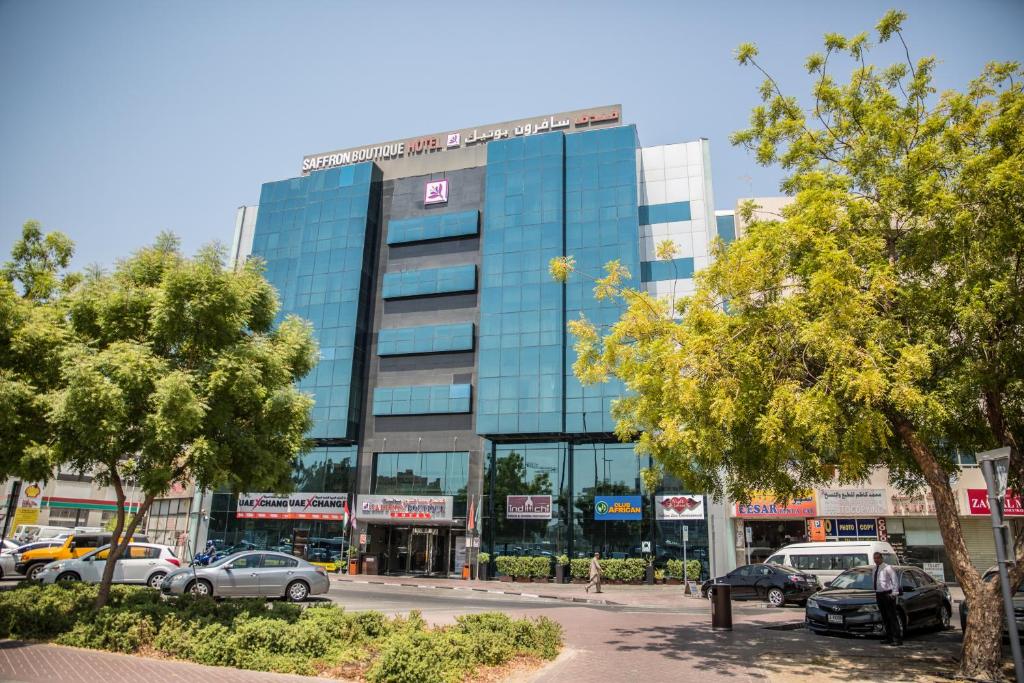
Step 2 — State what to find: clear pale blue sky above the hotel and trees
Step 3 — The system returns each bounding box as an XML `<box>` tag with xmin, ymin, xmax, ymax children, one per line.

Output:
<box><xmin>0</xmin><ymin>0</ymin><xmax>1024</xmax><ymax>266</ymax></box>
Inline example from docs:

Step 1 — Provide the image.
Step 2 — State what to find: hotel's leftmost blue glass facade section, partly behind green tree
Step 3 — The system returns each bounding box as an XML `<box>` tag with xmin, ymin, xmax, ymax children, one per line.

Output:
<box><xmin>252</xmin><ymin>163</ymin><xmax>380</xmax><ymax>439</ymax></box>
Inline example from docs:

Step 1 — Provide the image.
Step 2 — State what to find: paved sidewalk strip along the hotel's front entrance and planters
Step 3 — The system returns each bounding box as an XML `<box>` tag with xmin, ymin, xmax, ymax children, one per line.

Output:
<box><xmin>331</xmin><ymin>574</ymin><xmax>964</xmax><ymax>613</ymax></box>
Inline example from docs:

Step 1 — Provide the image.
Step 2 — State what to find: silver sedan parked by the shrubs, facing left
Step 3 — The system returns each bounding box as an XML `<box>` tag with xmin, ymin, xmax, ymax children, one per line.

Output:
<box><xmin>160</xmin><ymin>551</ymin><xmax>331</xmax><ymax>602</ymax></box>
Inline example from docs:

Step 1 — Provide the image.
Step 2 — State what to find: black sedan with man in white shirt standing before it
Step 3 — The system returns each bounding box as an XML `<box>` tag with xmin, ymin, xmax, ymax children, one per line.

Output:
<box><xmin>806</xmin><ymin>566</ymin><xmax>952</xmax><ymax>640</ymax></box>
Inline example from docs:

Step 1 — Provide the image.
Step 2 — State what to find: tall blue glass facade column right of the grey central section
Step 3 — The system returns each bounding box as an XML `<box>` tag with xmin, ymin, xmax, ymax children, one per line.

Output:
<box><xmin>476</xmin><ymin>133</ymin><xmax>565</xmax><ymax>434</ymax></box>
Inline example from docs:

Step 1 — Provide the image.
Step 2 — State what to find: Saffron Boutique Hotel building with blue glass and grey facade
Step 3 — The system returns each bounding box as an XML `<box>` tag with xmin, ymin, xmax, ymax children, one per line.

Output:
<box><xmin>210</xmin><ymin>105</ymin><xmax>732</xmax><ymax>575</ymax></box>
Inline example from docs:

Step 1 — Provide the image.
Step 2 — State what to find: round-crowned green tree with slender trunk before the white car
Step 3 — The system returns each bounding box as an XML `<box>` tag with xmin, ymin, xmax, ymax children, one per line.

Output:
<box><xmin>5</xmin><ymin>229</ymin><xmax>316</xmax><ymax>606</ymax></box>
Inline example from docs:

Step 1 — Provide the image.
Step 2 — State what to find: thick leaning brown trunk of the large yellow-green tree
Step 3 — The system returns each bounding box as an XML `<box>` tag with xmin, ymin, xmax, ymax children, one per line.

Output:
<box><xmin>892</xmin><ymin>416</ymin><xmax>1002</xmax><ymax>680</ymax></box>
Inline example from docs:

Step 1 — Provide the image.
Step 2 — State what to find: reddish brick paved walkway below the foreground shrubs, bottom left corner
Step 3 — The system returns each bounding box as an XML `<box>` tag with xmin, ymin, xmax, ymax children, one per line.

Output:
<box><xmin>0</xmin><ymin>640</ymin><xmax>338</xmax><ymax>683</ymax></box>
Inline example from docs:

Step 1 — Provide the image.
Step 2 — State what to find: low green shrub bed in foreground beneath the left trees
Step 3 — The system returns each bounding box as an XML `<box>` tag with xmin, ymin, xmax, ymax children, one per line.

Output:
<box><xmin>0</xmin><ymin>583</ymin><xmax>562</xmax><ymax>683</ymax></box>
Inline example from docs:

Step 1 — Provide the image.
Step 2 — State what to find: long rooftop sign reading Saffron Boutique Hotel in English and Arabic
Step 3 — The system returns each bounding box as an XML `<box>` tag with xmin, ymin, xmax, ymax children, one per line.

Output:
<box><xmin>302</xmin><ymin>104</ymin><xmax>623</xmax><ymax>175</ymax></box>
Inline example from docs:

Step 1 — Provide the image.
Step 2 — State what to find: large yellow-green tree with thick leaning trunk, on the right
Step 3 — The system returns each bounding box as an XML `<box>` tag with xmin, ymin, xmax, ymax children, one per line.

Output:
<box><xmin>552</xmin><ymin>11</ymin><xmax>1024</xmax><ymax>680</ymax></box>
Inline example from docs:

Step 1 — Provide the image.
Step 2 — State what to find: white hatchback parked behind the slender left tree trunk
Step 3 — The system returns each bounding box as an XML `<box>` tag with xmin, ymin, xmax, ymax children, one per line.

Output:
<box><xmin>38</xmin><ymin>543</ymin><xmax>181</xmax><ymax>588</ymax></box>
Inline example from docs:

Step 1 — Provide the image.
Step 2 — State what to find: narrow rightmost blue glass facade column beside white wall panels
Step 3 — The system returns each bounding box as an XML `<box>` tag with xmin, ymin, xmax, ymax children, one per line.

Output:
<box><xmin>563</xmin><ymin>126</ymin><xmax>640</xmax><ymax>434</ymax></box>
